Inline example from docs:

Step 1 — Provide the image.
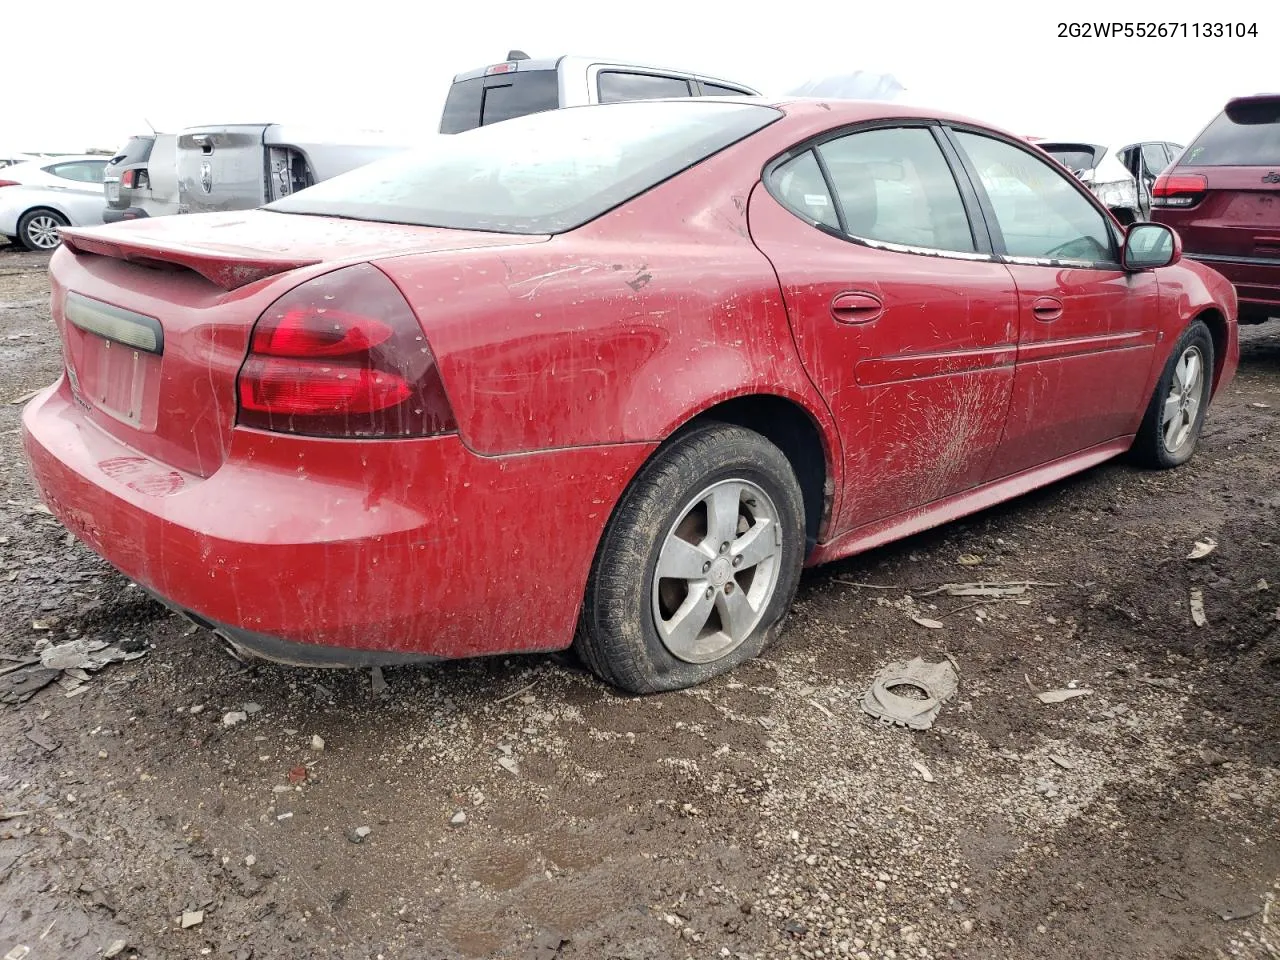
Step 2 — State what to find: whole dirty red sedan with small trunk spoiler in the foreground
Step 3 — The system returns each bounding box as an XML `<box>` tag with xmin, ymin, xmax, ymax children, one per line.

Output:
<box><xmin>23</xmin><ymin>100</ymin><xmax>1239</xmax><ymax>692</ymax></box>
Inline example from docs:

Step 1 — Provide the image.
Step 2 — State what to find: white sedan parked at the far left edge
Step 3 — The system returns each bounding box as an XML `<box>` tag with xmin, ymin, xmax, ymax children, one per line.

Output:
<box><xmin>0</xmin><ymin>155</ymin><xmax>108</xmax><ymax>250</ymax></box>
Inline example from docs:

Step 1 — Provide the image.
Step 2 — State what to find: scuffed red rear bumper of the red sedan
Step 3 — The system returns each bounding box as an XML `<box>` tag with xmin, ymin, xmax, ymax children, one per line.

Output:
<box><xmin>23</xmin><ymin>380</ymin><xmax>652</xmax><ymax>664</ymax></box>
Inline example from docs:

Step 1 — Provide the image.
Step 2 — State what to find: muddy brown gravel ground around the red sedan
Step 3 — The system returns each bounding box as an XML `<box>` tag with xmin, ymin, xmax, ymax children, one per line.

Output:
<box><xmin>0</xmin><ymin>239</ymin><xmax>1280</xmax><ymax>960</ymax></box>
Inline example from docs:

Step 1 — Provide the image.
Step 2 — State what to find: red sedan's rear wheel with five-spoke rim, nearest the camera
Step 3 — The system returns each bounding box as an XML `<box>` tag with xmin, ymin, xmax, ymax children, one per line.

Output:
<box><xmin>573</xmin><ymin>424</ymin><xmax>805</xmax><ymax>694</ymax></box>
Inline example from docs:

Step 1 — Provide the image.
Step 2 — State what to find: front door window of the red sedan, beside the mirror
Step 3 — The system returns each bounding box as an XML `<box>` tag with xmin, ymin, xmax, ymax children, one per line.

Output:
<box><xmin>955</xmin><ymin>131</ymin><xmax>1116</xmax><ymax>264</ymax></box>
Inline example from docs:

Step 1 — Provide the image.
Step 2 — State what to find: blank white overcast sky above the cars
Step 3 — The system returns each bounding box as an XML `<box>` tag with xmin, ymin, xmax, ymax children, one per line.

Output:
<box><xmin>0</xmin><ymin>0</ymin><xmax>1280</xmax><ymax>151</ymax></box>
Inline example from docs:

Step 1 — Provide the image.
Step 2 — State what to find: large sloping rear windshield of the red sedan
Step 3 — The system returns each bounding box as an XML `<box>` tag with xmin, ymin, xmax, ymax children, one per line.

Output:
<box><xmin>265</xmin><ymin>100</ymin><xmax>782</xmax><ymax>234</ymax></box>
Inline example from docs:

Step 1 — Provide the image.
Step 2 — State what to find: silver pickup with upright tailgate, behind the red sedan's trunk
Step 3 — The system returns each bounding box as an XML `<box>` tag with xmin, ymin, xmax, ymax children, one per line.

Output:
<box><xmin>177</xmin><ymin>123</ymin><xmax>410</xmax><ymax>214</ymax></box>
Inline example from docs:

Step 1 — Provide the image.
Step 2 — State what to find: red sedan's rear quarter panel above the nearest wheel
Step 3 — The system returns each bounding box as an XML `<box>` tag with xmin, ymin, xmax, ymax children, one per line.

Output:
<box><xmin>379</xmin><ymin>131</ymin><xmax>838</xmax><ymax>467</ymax></box>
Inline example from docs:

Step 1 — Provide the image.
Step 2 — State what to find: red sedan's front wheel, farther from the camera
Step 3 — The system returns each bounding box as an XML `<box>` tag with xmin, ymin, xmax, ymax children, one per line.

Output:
<box><xmin>1133</xmin><ymin>320</ymin><xmax>1213</xmax><ymax>470</ymax></box>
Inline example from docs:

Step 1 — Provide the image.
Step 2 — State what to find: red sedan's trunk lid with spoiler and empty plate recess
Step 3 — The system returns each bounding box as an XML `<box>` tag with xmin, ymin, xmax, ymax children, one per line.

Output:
<box><xmin>50</xmin><ymin>211</ymin><xmax>547</xmax><ymax>476</ymax></box>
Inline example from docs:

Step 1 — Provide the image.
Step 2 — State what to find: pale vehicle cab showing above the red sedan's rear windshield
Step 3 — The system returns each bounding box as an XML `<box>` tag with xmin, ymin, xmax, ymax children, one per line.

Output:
<box><xmin>440</xmin><ymin>50</ymin><xmax>760</xmax><ymax>133</ymax></box>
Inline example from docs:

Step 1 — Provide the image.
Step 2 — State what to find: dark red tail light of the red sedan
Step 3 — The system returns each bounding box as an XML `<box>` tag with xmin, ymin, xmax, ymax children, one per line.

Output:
<box><xmin>237</xmin><ymin>264</ymin><xmax>457</xmax><ymax>438</ymax></box>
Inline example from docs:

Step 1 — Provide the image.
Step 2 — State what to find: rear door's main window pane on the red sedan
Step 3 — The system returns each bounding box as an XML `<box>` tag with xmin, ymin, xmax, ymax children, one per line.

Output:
<box><xmin>818</xmin><ymin>127</ymin><xmax>974</xmax><ymax>252</ymax></box>
